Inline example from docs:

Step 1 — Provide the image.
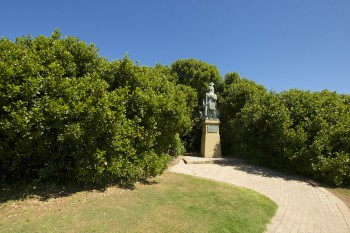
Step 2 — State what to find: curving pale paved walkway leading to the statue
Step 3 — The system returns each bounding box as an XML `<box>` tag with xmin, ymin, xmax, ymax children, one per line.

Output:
<box><xmin>169</xmin><ymin>157</ymin><xmax>350</xmax><ymax>233</ymax></box>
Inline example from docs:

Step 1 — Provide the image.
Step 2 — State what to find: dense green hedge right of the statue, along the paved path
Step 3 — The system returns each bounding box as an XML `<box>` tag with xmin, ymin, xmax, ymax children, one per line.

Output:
<box><xmin>221</xmin><ymin>73</ymin><xmax>350</xmax><ymax>185</ymax></box>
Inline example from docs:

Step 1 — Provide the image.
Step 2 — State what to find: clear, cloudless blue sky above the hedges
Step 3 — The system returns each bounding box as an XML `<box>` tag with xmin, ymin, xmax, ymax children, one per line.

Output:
<box><xmin>0</xmin><ymin>0</ymin><xmax>350</xmax><ymax>94</ymax></box>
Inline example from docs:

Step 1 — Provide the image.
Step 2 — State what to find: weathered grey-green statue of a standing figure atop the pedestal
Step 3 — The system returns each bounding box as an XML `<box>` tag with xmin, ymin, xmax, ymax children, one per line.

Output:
<box><xmin>200</xmin><ymin>82</ymin><xmax>219</xmax><ymax>120</ymax></box>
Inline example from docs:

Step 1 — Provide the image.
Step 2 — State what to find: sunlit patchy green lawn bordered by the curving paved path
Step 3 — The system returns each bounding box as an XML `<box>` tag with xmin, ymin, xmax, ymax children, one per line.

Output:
<box><xmin>0</xmin><ymin>172</ymin><xmax>277</xmax><ymax>233</ymax></box>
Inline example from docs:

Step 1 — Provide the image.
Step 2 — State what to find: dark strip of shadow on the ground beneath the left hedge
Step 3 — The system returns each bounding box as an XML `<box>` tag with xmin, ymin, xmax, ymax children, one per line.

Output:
<box><xmin>0</xmin><ymin>179</ymin><xmax>158</xmax><ymax>204</ymax></box>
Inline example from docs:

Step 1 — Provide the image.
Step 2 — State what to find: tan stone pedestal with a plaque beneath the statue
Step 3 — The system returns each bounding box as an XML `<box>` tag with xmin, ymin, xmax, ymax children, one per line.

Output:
<box><xmin>201</xmin><ymin>119</ymin><xmax>221</xmax><ymax>158</ymax></box>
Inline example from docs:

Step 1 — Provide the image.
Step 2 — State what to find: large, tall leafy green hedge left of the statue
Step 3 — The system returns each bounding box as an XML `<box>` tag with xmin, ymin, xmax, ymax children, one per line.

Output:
<box><xmin>0</xmin><ymin>31</ymin><xmax>196</xmax><ymax>183</ymax></box>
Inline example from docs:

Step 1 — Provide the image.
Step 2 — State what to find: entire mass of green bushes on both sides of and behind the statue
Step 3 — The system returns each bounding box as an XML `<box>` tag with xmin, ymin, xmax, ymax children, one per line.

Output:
<box><xmin>0</xmin><ymin>30</ymin><xmax>350</xmax><ymax>185</ymax></box>
